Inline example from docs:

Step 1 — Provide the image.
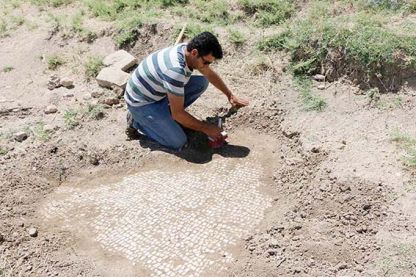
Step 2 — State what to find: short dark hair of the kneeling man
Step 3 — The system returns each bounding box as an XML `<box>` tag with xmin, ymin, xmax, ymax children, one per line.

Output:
<box><xmin>186</xmin><ymin>32</ymin><xmax>222</xmax><ymax>60</ymax></box>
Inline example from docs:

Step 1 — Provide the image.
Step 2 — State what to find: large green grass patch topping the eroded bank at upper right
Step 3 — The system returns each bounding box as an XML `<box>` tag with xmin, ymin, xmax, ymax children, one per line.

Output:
<box><xmin>258</xmin><ymin>1</ymin><xmax>416</xmax><ymax>82</ymax></box>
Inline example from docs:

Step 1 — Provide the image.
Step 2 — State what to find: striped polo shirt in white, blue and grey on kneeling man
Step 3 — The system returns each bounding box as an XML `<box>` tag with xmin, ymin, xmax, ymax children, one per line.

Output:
<box><xmin>124</xmin><ymin>43</ymin><xmax>192</xmax><ymax>107</ymax></box>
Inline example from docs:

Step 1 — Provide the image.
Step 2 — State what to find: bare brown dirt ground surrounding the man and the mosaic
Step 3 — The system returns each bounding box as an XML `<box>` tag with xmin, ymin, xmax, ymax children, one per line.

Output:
<box><xmin>0</xmin><ymin>2</ymin><xmax>416</xmax><ymax>276</ymax></box>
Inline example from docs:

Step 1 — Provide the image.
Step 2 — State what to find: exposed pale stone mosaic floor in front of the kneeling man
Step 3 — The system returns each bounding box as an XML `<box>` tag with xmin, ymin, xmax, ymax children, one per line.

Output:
<box><xmin>43</xmin><ymin>159</ymin><xmax>272</xmax><ymax>276</ymax></box>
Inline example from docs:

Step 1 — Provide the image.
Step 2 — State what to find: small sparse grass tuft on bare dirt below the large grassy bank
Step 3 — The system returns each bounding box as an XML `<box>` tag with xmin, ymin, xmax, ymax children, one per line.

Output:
<box><xmin>294</xmin><ymin>77</ymin><xmax>327</xmax><ymax>112</ymax></box>
